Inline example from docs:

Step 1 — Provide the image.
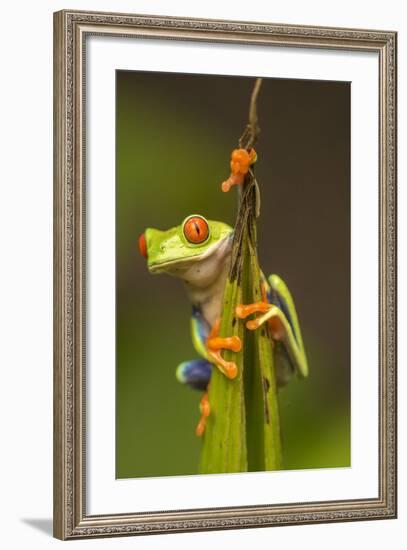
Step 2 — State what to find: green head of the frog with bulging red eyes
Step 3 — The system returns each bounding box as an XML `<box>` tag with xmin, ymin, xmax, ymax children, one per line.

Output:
<box><xmin>139</xmin><ymin>218</ymin><xmax>233</xmax><ymax>283</ymax></box>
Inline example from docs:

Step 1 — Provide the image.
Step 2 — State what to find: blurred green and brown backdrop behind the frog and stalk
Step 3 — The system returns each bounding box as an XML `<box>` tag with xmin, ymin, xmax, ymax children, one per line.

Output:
<box><xmin>116</xmin><ymin>71</ymin><xmax>350</xmax><ymax>478</ymax></box>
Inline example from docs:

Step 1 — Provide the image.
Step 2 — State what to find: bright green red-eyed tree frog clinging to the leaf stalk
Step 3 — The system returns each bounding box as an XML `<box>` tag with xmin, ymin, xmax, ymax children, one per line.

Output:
<box><xmin>139</xmin><ymin>216</ymin><xmax>308</xmax><ymax>435</ymax></box>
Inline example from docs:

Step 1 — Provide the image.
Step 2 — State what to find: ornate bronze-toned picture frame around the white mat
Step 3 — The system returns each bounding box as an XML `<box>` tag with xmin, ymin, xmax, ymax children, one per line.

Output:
<box><xmin>54</xmin><ymin>10</ymin><xmax>397</xmax><ymax>540</ymax></box>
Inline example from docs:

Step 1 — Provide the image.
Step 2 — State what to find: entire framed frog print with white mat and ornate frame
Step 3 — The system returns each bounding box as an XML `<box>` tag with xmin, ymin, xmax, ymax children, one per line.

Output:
<box><xmin>54</xmin><ymin>10</ymin><xmax>396</xmax><ymax>539</ymax></box>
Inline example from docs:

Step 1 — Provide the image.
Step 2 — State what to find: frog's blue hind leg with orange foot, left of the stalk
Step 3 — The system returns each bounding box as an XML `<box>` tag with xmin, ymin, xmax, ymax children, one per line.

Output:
<box><xmin>176</xmin><ymin>359</ymin><xmax>212</xmax><ymax>436</ymax></box>
